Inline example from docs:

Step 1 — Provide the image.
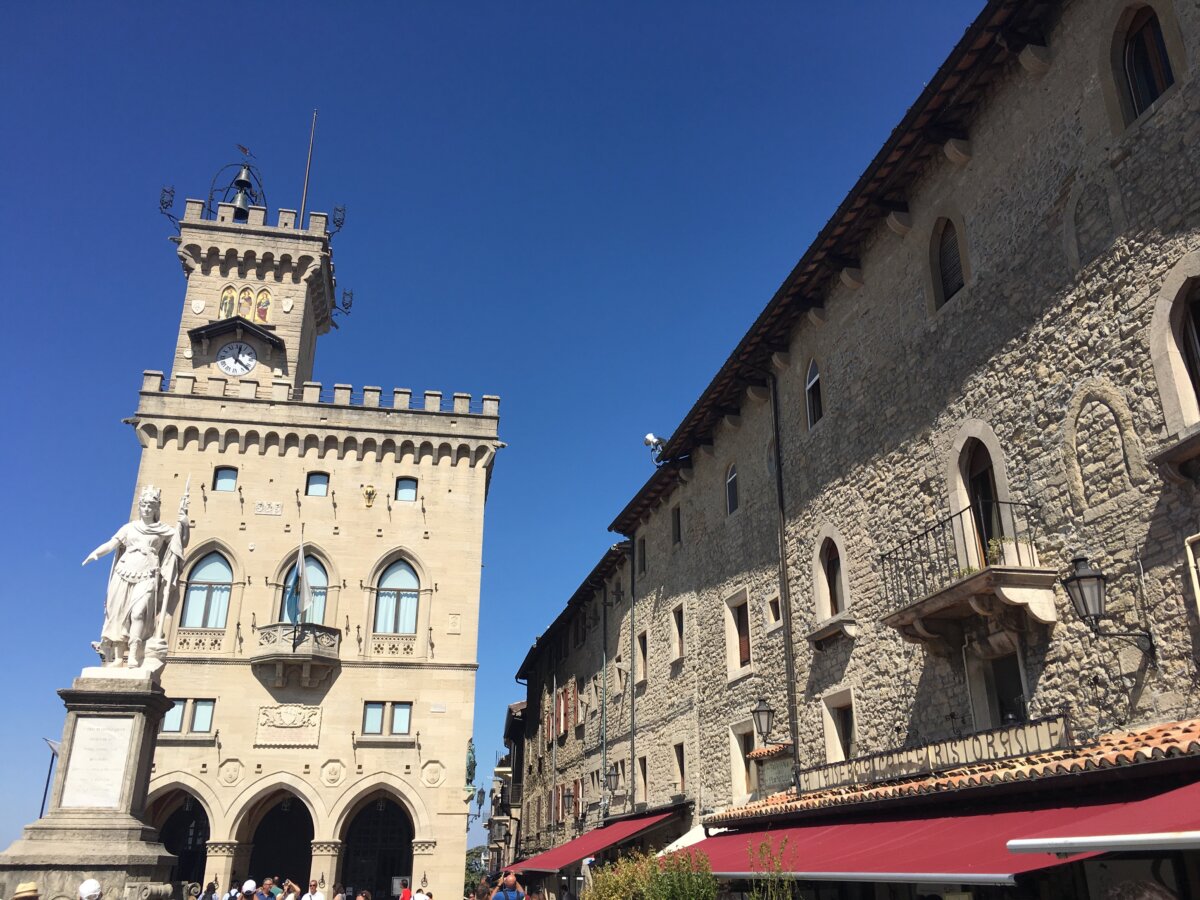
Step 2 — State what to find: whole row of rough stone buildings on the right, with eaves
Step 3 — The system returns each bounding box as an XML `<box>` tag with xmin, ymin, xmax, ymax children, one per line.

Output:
<box><xmin>506</xmin><ymin>0</ymin><xmax>1200</xmax><ymax>883</ymax></box>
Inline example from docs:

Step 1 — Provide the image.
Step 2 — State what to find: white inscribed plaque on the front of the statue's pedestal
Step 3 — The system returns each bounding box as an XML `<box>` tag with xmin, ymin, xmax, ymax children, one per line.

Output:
<box><xmin>59</xmin><ymin>715</ymin><xmax>133</xmax><ymax>809</ymax></box>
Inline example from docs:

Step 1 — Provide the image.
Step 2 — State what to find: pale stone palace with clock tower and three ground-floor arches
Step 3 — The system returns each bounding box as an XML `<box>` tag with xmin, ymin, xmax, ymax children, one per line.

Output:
<box><xmin>118</xmin><ymin>188</ymin><xmax>499</xmax><ymax>895</ymax></box>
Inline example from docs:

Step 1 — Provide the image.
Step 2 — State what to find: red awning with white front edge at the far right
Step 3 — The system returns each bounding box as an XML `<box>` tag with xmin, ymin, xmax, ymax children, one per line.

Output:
<box><xmin>1008</xmin><ymin>782</ymin><xmax>1200</xmax><ymax>853</ymax></box>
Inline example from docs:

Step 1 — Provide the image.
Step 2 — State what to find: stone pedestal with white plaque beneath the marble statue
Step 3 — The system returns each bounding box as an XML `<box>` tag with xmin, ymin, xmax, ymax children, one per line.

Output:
<box><xmin>0</xmin><ymin>668</ymin><xmax>175</xmax><ymax>900</ymax></box>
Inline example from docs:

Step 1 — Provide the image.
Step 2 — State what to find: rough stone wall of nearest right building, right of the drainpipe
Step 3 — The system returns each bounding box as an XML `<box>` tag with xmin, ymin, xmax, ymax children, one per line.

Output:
<box><xmin>781</xmin><ymin>2</ymin><xmax>1200</xmax><ymax>764</ymax></box>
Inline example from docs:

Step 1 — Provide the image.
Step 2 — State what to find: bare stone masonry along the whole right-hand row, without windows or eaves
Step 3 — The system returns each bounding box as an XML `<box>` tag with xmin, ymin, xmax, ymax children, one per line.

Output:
<box><xmin>516</xmin><ymin>0</ymin><xmax>1200</xmax><ymax>842</ymax></box>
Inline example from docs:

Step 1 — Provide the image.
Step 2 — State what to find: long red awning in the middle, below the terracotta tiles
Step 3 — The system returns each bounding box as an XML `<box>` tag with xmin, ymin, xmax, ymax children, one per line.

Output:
<box><xmin>682</xmin><ymin>804</ymin><xmax>1114</xmax><ymax>884</ymax></box>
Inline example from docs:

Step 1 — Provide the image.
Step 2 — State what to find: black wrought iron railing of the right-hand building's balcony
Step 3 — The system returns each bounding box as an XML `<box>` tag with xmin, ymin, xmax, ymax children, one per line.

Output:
<box><xmin>880</xmin><ymin>500</ymin><xmax>1039</xmax><ymax>613</ymax></box>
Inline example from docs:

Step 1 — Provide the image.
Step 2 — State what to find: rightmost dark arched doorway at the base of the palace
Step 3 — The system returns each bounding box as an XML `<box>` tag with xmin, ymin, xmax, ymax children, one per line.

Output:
<box><xmin>342</xmin><ymin>793</ymin><xmax>414</xmax><ymax>899</ymax></box>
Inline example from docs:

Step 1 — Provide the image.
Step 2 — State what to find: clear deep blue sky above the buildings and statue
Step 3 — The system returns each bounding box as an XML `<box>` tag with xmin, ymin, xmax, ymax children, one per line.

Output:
<box><xmin>0</xmin><ymin>0</ymin><xmax>982</xmax><ymax>846</ymax></box>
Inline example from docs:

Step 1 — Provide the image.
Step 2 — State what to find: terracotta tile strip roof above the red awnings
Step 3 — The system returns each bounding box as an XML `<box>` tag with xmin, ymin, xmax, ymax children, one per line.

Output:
<box><xmin>704</xmin><ymin>719</ymin><xmax>1200</xmax><ymax>824</ymax></box>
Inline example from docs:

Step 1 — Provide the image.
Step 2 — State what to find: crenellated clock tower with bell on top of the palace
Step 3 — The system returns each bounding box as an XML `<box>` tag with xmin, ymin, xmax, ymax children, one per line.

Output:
<box><xmin>173</xmin><ymin>167</ymin><xmax>335</xmax><ymax>392</ymax></box>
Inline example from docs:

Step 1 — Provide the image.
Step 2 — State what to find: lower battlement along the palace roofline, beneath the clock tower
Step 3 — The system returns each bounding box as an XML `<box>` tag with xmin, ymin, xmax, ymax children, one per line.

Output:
<box><xmin>142</xmin><ymin>370</ymin><xmax>500</xmax><ymax>416</ymax></box>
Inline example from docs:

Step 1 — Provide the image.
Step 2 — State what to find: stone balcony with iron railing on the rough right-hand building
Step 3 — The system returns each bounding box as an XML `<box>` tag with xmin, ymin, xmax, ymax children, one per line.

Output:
<box><xmin>880</xmin><ymin>500</ymin><xmax>1058</xmax><ymax>655</ymax></box>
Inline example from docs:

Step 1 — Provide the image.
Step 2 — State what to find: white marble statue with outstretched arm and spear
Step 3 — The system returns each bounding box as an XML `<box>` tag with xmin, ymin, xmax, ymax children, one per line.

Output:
<box><xmin>83</xmin><ymin>482</ymin><xmax>190</xmax><ymax>672</ymax></box>
